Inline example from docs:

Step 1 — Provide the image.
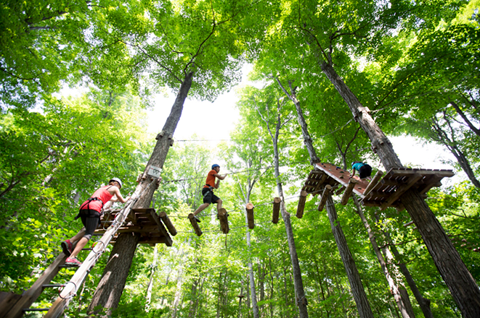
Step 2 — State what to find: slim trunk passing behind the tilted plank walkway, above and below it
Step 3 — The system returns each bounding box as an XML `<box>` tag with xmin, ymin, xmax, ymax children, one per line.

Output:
<box><xmin>286</xmin><ymin>84</ymin><xmax>373</xmax><ymax>317</ymax></box>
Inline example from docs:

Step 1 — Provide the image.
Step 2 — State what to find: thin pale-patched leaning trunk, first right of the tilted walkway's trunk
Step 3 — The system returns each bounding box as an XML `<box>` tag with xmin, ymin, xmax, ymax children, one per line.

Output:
<box><xmin>353</xmin><ymin>194</ymin><xmax>415</xmax><ymax>318</ymax></box>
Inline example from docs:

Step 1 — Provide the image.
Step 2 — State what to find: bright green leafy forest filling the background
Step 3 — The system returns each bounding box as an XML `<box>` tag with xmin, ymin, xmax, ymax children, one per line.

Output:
<box><xmin>0</xmin><ymin>0</ymin><xmax>480</xmax><ymax>317</ymax></box>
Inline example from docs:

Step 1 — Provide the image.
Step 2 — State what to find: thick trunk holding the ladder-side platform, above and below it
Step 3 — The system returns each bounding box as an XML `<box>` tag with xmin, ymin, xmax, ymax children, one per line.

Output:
<box><xmin>88</xmin><ymin>73</ymin><xmax>193</xmax><ymax>312</ymax></box>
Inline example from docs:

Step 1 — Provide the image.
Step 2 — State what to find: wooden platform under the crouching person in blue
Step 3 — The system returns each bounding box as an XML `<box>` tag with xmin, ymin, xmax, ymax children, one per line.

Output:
<box><xmin>302</xmin><ymin>163</ymin><xmax>454</xmax><ymax>210</ymax></box>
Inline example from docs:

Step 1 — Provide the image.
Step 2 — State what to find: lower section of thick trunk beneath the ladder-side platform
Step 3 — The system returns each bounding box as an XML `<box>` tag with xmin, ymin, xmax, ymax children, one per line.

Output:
<box><xmin>88</xmin><ymin>233</ymin><xmax>140</xmax><ymax>316</ymax></box>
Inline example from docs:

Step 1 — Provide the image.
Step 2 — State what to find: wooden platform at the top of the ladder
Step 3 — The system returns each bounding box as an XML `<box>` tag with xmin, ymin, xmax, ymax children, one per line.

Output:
<box><xmin>95</xmin><ymin>208</ymin><xmax>177</xmax><ymax>246</ymax></box>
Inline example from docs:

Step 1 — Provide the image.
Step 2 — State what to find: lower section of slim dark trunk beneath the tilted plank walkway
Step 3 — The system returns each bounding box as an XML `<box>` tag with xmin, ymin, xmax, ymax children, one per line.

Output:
<box><xmin>326</xmin><ymin>195</ymin><xmax>373</xmax><ymax>318</ymax></box>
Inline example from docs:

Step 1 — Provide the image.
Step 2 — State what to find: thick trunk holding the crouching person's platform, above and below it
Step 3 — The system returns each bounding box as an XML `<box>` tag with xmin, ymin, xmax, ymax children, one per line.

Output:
<box><xmin>321</xmin><ymin>62</ymin><xmax>480</xmax><ymax>317</ymax></box>
